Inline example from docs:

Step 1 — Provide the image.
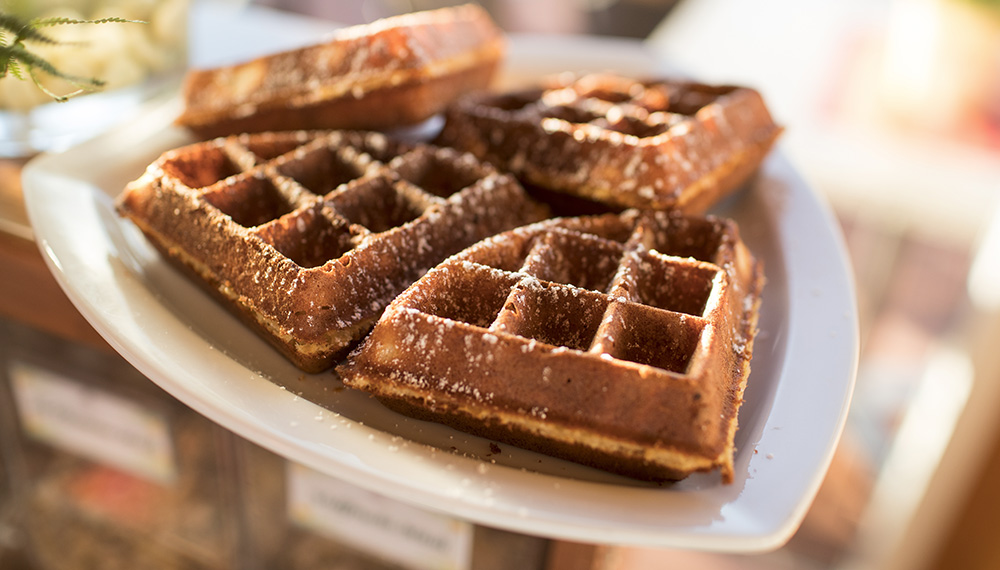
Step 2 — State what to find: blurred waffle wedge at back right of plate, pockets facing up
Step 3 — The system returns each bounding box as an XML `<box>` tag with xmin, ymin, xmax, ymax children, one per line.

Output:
<box><xmin>438</xmin><ymin>74</ymin><xmax>781</xmax><ymax>214</ymax></box>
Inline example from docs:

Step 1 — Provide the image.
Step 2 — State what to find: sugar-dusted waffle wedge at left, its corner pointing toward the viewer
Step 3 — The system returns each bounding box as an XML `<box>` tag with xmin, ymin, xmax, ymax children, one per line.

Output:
<box><xmin>117</xmin><ymin>131</ymin><xmax>547</xmax><ymax>372</ymax></box>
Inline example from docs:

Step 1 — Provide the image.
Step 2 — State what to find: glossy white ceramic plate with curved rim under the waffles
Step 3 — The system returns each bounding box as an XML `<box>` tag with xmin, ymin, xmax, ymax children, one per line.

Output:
<box><xmin>24</xmin><ymin>33</ymin><xmax>857</xmax><ymax>552</ymax></box>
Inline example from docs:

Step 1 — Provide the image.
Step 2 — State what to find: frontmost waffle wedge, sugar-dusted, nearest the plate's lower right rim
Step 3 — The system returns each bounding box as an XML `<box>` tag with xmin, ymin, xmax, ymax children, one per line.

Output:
<box><xmin>337</xmin><ymin>210</ymin><xmax>764</xmax><ymax>483</ymax></box>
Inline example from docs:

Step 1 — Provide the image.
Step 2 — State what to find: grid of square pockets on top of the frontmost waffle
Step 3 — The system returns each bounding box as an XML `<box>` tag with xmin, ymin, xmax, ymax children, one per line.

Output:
<box><xmin>420</xmin><ymin>215</ymin><xmax>724</xmax><ymax>374</ymax></box>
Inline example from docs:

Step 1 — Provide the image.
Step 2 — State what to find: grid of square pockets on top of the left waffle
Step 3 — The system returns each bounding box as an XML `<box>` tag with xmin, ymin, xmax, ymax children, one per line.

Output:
<box><xmin>179</xmin><ymin>135</ymin><xmax>495</xmax><ymax>268</ymax></box>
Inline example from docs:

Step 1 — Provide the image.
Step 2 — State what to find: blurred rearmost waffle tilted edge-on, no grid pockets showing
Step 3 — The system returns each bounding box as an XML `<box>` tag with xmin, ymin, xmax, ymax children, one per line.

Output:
<box><xmin>177</xmin><ymin>5</ymin><xmax>504</xmax><ymax>138</ymax></box>
